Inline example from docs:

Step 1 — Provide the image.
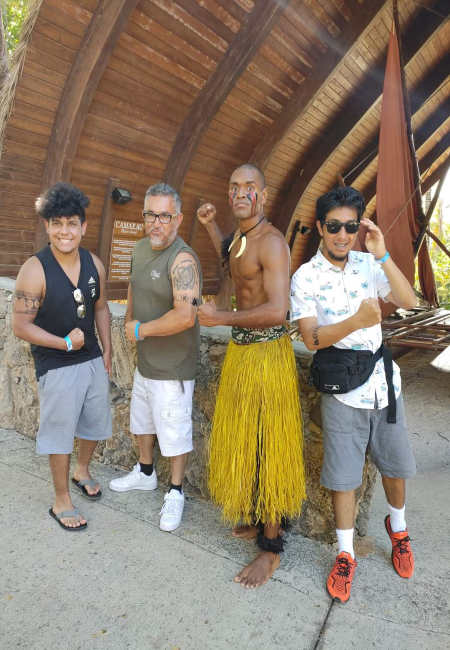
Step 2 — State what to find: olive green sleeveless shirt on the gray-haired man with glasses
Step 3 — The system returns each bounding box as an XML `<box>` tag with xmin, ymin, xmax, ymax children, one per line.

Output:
<box><xmin>130</xmin><ymin>237</ymin><xmax>202</xmax><ymax>380</ymax></box>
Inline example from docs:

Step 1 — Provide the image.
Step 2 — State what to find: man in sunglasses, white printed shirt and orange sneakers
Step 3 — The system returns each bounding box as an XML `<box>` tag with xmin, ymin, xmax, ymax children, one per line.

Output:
<box><xmin>291</xmin><ymin>187</ymin><xmax>416</xmax><ymax>602</ymax></box>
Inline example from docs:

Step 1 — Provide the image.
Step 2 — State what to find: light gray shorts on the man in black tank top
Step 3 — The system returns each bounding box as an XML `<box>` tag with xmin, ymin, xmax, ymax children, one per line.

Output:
<box><xmin>36</xmin><ymin>357</ymin><xmax>112</xmax><ymax>454</ymax></box>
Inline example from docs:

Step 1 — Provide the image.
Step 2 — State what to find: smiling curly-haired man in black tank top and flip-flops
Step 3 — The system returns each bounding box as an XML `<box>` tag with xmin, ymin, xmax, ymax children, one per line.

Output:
<box><xmin>13</xmin><ymin>183</ymin><xmax>111</xmax><ymax>531</ymax></box>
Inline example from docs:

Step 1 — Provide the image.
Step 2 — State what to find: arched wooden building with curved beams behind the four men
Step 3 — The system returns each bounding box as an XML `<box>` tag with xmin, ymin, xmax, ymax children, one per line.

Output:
<box><xmin>0</xmin><ymin>0</ymin><xmax>450</xmax><ymax>296</ymax></box>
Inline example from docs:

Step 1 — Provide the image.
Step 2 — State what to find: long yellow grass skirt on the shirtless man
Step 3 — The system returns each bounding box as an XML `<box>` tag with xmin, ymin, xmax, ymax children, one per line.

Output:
<box><xmin>209</xmin><ymin>335</ymin><xmax>305</xmax><ymax>524</ymax></box>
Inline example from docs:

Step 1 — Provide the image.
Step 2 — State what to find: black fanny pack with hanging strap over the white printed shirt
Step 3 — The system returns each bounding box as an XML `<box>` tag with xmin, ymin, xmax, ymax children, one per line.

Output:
<box><xmin>311</xmin><ymin>345</ymin><xmax>396</xmax><ymax>423</ymax></box>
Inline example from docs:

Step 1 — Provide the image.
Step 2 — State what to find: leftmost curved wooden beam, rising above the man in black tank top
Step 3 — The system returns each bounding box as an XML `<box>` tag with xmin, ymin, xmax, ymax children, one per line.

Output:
<box><xmin>36</xmin><ymin>0</ymin><xmax>139</xmax><ymax>246</ymax></box>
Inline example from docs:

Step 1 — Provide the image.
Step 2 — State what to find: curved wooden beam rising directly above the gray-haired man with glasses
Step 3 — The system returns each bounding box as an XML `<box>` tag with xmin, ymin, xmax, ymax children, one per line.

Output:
<box><xmin>164</xmin><ymin>0</ymin><xmax>289</xmax><ymax>191</ymax></box>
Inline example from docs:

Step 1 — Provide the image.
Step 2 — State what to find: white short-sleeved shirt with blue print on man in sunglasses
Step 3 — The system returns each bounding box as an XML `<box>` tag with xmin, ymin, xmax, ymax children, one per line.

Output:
<box><xmin>291</xmin><ymin>250</ymin><xmax>401</xmax><ymax>409</ymax></box>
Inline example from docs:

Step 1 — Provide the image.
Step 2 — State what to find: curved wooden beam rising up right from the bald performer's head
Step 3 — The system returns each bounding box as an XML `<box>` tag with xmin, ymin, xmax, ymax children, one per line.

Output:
<box><xmin>250</xmin><ymin>0</ymin><xmax>385</xmax><ymax>169</ymax></box>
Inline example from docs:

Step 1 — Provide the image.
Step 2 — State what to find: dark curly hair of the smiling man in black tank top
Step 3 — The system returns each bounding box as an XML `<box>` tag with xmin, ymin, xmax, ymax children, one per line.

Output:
<box><xmin>35</xmin><ymin>182</ymin><xmax>89</xmax><ymax>223</ymax></box>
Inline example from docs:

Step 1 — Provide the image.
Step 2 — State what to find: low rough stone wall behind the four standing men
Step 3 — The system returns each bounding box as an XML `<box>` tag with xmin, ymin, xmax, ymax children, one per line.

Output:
<box><xmin>0</xmin><ymin>278</ymin><xmax>375</xmax><ymax>541</ymax></box>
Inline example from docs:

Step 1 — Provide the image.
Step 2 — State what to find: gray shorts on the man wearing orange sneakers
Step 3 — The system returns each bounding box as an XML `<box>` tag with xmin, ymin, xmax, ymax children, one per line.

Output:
<box><xmin>320</xmin><ymin>394</ymin><xmax>416</xmax><ymax>492</ymax></box>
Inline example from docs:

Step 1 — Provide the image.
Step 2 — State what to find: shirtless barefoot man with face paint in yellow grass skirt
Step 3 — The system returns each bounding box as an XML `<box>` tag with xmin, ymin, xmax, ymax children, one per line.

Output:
<box><xmin>197</xmin><ymin>164</ymin><xmax>305</xmax><ymax>589</ymax></box>
